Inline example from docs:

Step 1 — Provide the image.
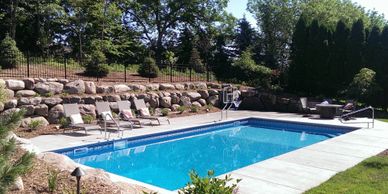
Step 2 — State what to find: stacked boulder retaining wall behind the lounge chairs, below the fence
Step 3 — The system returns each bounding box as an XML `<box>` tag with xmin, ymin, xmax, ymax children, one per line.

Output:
<box><xmin>0</xmin><ymin>78</ymin><xmax>221</xmax><ymax>125</ymax></box>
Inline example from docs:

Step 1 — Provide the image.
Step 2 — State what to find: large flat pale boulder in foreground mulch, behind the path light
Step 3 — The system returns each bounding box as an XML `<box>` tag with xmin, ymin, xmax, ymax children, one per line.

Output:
<box><xmin>38</xmin><ymin>152</ymin><xmax>77</xmax><ymax>172</ymax></box>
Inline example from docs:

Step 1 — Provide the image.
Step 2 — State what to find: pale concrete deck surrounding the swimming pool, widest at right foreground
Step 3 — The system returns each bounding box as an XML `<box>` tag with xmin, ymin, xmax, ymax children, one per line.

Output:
<box><xmin>31</xmin><ymin>111</ymin><xmax>388</xmax><ymax>194</ymax></box>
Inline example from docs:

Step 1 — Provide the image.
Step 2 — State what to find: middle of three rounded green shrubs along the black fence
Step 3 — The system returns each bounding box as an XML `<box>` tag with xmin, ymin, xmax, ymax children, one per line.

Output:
<box><xmin>84</xmin><ymin>49</ymin><xmax>109</xmax><ymax>77</ymax></box>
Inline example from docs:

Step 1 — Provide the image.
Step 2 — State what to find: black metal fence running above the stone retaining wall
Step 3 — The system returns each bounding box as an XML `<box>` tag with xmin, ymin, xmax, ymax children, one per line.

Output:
<box><xmin>0</xmin><ymin>53</ymin><xmax>216</xmax><ymax>82</ymax></box>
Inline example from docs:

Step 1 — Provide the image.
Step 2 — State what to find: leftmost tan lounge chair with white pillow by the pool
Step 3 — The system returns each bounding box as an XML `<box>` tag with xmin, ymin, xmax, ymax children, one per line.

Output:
<box><xmin>63</xmin><ymin>104</ymin><xmax>101</xmax><ymax>133</ymax></box>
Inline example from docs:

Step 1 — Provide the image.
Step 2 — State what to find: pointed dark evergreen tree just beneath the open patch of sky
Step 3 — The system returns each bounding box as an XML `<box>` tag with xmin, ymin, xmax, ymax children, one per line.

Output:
<box><xmin>235</xmin><ymin>16</ymin><xmax>256</xmax><ymax>55</ymax></box>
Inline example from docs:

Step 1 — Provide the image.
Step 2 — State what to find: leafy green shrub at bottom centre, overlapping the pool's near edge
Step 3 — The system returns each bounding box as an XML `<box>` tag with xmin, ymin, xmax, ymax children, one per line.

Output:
<box><xmin>178</xmin><ymin>170</ymin><xmax>241</xmax><ymax>194</ymax></box>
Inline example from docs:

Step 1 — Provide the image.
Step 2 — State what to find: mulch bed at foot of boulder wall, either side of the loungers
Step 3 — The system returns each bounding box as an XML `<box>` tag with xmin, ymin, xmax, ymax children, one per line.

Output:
<box><xmin>14</xmin><ymin>107</ymin><xmax>220</xmax><ymax>139</ymax></box>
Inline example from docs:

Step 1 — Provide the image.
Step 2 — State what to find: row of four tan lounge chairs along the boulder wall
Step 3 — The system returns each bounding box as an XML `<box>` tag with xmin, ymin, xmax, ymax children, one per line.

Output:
<box><xmin>63</xmin><ymin>99</ymin><xmax>170</xmax><ymax>139</ymax></box>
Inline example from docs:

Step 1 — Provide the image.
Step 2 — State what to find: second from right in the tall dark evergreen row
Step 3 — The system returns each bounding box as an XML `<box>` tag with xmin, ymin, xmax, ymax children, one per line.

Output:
<box><xmin>344</xmin><ymin>19</ymin><xmax>365</xmax><ymax>84</ymax></box>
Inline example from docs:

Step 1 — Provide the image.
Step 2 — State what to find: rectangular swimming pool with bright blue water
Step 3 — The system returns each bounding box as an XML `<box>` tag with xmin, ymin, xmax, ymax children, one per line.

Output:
<box><xmin>56</xmin><ymin>118</ymin><xmax>354</xmax><ymax>190</ymax></box>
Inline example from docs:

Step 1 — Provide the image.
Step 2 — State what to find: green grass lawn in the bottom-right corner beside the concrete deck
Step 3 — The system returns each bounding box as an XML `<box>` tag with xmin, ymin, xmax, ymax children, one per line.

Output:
<box><xmin>305</xmin><ymin>151</ymin><xmax>388</xmax><ymax>194</ymax></box>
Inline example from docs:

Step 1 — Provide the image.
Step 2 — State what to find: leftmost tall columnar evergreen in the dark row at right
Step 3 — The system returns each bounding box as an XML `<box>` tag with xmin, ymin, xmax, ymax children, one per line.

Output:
<box><xmin>288</xmin><ymin>15</ymin><xmax>308</xmax><ymax>92</ymax></box>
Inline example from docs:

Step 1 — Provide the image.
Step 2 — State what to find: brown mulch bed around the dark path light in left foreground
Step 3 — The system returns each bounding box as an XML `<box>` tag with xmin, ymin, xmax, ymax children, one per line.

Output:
<box><xmin>9</xmin><ymin>149</ymin><xmax>120</xmax><ymax>194</ymax></box>
